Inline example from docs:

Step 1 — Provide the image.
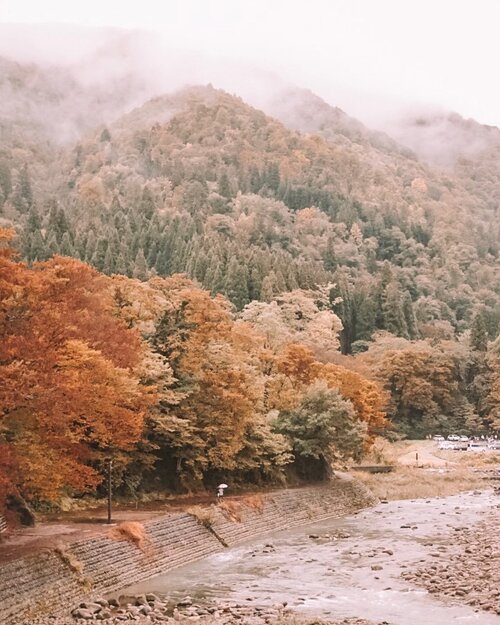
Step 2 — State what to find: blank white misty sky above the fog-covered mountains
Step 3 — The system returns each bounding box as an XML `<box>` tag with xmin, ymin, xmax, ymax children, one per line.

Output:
<box><xmin>0</xmin><ymin>0</ymin><xmax>500</xmax><ymax>126</ymax></box>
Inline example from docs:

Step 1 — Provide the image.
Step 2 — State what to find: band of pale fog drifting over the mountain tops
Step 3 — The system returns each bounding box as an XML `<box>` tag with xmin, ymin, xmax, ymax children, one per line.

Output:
<box><xmin>0</xmin><ymin>24</ymin><xmax>498</xmax><ymax>173</ymax></box>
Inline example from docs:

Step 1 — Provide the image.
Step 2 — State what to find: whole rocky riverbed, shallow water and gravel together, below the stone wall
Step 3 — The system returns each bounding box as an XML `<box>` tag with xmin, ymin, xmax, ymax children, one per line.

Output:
<box><xmin>25</xmin><ymin>489</ymin><xmax>500</xmax><ymax>625</ymax></box>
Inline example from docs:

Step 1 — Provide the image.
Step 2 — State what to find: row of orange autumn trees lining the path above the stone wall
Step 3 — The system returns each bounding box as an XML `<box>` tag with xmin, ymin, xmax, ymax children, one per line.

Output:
<box><xmin>0</xmin><ymin>231</ymin><xmax>385</xmax><ymax>510</ymax></box>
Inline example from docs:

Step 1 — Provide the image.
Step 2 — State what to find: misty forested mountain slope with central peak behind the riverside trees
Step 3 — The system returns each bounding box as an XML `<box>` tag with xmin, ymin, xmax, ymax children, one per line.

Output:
<box><xmin>4</xmin><ymin>78</ymin><xmax>500</xmax><ymax>352</ymax></box>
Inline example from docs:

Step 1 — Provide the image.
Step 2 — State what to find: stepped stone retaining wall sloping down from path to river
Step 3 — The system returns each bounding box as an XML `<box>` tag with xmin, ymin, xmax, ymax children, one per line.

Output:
<box><xmin>0</xmin><ymin>479</ymin><xmax>374</xmax><ymax>625</ymax></box>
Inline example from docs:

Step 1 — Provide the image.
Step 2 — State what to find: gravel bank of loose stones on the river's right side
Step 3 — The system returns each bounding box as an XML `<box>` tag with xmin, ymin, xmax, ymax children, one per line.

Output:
<box><xmin>402</xmin><ymin>504</ymin><xmax>500</xmax><ymax>615</ymax></box>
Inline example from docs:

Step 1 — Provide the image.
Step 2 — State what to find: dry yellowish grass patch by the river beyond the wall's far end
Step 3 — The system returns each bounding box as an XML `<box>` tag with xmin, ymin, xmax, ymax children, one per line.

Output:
<box><xmin>356</xmin><ymin>467</ymin><xmax>485</xmax><ymax>500</ymax></box>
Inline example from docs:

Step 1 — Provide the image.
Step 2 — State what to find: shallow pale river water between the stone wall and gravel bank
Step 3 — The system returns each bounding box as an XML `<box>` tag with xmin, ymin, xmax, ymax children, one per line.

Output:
<box><xmin>123</xmin><ymin>493</ymin><xmax>500</xmax><ymax>625</ymax></box>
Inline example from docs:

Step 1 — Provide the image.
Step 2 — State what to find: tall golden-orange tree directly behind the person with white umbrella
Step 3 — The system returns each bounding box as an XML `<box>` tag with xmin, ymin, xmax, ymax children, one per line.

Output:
<box><xmin>151</xmin><ymin>276</ymin><xmax>263</xmax><ymax>488</ymax></box>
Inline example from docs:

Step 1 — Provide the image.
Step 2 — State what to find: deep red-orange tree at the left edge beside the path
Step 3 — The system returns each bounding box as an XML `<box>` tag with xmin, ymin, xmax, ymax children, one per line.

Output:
<box><xmin>0</xmin><ymin>231</ymin><xmax>154</xmax><ymax>510</ymax></box>
